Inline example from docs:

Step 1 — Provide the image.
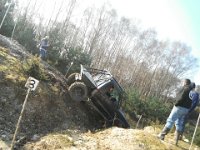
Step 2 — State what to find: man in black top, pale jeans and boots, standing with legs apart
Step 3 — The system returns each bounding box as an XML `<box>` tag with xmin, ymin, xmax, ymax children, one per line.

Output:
<box><xmin>158</xmin><ymin>79</ymin><xmax>192</xmax><ymax>145</ymax></box>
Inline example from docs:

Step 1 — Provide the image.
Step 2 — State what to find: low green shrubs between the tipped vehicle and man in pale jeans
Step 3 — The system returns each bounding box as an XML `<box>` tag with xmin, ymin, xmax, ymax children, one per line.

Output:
<box><xmin>125</xmin><ymin>88</ymin><xmax>172</xmax><ymax>125</ymax></box>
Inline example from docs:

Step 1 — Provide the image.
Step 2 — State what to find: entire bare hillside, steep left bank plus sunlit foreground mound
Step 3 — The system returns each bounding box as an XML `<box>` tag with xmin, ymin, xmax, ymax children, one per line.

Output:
<box><xmin>0</xmin><ymin>35</ymin><xmax>198</xmax><ymax>150</ymax></box>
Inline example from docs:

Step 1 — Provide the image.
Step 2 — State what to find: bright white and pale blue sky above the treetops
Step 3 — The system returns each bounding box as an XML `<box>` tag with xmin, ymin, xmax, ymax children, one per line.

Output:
<box><xmin>19</xmin><ymin>0</ymin><xmax>200</xmax><ymax>85</ymax></box>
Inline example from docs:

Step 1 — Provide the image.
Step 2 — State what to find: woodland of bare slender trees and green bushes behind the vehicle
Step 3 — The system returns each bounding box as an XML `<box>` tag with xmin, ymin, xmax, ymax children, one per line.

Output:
<box><xmin>0</xmin><ymin>0</ymin><xmax>200</xmax><ymax>143</ymax></box>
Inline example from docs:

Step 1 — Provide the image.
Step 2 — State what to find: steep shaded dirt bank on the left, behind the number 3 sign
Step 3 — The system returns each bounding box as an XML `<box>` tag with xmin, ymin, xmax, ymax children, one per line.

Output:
<box><xmin>0</xmin><ymin>35</ymin><xmax>102</xmax><ymax>149</ymax></box>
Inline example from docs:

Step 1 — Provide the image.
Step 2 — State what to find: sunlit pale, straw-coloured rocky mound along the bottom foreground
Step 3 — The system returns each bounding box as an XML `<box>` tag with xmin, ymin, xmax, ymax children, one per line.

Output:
<box><xmin>23</xmin><ymin>127</ymin><xmax>199</xmax><ymax>150</ymax></box>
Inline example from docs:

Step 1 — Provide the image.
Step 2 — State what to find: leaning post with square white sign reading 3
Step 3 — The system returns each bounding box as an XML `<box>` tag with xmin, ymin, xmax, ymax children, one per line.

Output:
<box><xmin>11</xmin><ymin>77</ymin><xmax>39</xmax><ymax>150</ymax></box>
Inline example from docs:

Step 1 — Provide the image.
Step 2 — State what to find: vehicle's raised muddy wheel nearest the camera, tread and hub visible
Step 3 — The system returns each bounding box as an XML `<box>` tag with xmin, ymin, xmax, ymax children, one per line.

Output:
<box><xmin>69</xmin><ymin>82</ymin><xmax>88</xmax><ymax>102</ymax></box>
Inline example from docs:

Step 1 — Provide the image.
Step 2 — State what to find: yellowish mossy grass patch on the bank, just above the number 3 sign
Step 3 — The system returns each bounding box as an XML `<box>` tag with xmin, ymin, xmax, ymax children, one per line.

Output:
<box><xmin>0</xmin><ymin>47</ymin><xmax>50</xmax><ymax>87</ymax></box>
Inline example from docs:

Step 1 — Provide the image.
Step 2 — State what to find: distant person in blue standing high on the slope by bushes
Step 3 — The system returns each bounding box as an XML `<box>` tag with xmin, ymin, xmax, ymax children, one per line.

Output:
<box><xmin>39</xmin><ymin>36</ymin><xmax>49</xmax><ymax>60</ymax></box>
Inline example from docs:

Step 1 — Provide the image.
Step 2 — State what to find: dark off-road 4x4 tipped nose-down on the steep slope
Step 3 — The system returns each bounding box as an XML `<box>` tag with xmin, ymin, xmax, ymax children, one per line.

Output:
<box><xmin>67</xmin><ymin>65</ymin><xmax>130</xmax><ymax>128</ymax></box>
